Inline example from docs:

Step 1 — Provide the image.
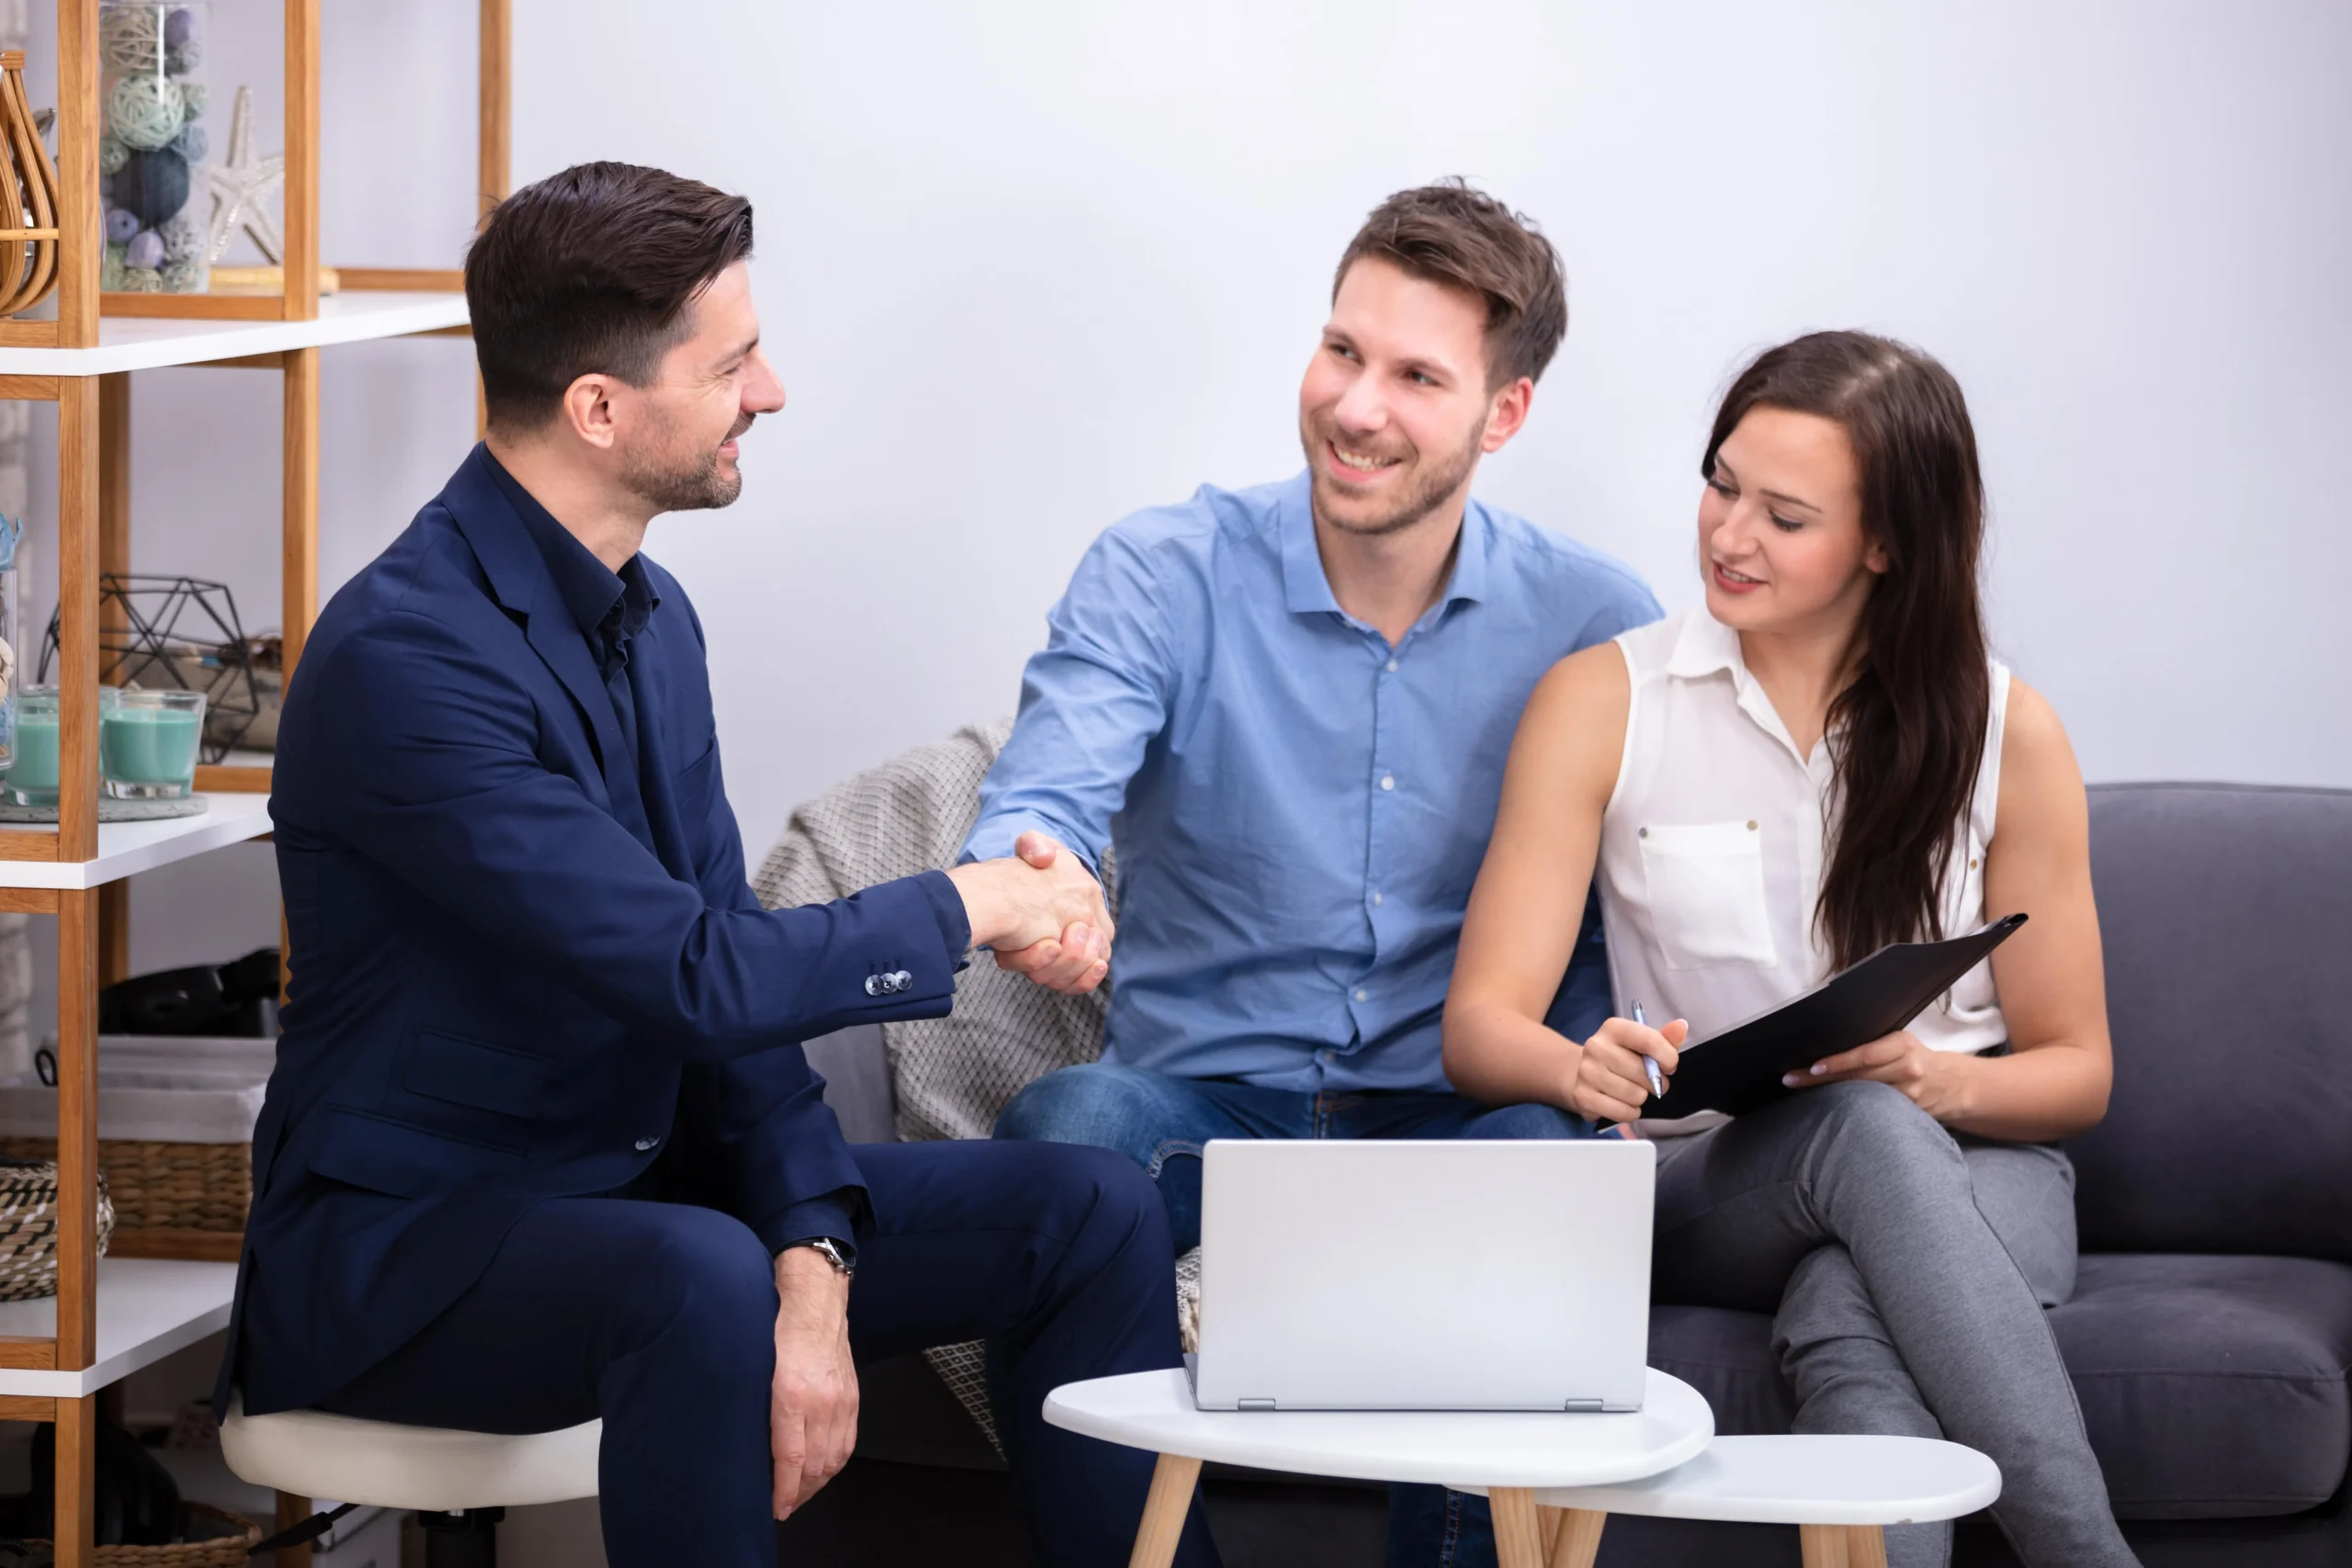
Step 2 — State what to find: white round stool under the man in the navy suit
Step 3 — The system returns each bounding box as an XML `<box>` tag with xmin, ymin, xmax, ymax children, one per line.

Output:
<box><xmin>221</xmin><ymin>1396</ymin><xmax>605</xmax><ymax>1568</ymax></box>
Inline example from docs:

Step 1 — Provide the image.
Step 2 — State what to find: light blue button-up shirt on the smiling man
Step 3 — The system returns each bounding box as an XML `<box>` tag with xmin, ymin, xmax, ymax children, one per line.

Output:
<box><xmin>965</xmin><ymin>475</ymin><xmax>1660</xmax><ymax>1090</ymax></box>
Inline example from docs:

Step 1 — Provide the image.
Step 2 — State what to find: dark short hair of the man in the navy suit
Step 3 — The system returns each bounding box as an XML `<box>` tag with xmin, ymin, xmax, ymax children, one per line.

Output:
<box><xmin>466</xmin><ymin>163</ymin><xmax>751</xmax><ymax>430</ymax></box>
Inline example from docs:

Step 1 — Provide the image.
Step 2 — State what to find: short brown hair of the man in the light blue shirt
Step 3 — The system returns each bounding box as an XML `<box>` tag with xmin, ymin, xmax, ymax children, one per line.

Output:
<box><xmin>1331</xmin><ymin>176</ymin><xmax>1569</xmax><ymax>386</ymax></box>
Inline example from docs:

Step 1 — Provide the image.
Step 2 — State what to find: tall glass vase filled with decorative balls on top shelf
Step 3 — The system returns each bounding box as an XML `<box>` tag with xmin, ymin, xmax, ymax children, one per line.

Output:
<box><xmin>99</xmin><ymin>0</ymin><xmax>211</xmax><ymax>294</ymax></box>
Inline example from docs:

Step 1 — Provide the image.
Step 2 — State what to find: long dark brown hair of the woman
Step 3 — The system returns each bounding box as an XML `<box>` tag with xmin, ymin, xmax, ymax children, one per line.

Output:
<box><xmin>1698</xmin><ymin>332</ymin><xmax>1992</xmax><ymax>968</ymax></box>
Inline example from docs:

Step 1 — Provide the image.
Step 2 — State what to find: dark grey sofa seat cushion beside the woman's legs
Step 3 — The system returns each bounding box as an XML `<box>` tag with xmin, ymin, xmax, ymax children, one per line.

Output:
<box><xmin>2051</xmin><ymin>1253</ymin><xmax>2352</xmax><ymax>1518</ymax></box>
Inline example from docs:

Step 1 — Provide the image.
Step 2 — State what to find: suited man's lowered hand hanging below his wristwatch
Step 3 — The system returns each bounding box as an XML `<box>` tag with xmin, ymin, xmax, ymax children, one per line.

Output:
<box><xmin>767</xmin><ymin>1246</ymin><xmax>858</xmax><ymax>1518</ymax></box>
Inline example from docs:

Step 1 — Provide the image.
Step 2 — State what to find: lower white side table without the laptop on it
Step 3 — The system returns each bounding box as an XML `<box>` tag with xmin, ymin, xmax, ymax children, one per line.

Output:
<box><xmin>1458</xmin><ymin>1437</ymin><xmax>2002</xmax><ymax>1568</ymax></box>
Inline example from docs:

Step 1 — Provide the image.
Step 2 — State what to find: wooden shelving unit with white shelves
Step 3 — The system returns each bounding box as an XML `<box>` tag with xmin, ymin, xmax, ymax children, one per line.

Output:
<box><xmin>0</xmin><ymin>0</ymin><xmax>511</xmax><ymax>1568</ymax></box>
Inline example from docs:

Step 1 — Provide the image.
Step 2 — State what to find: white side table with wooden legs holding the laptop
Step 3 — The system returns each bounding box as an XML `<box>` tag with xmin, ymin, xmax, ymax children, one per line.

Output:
<box><xmin>1045</xmin><ymin>1368</ymin><xmax>1714</xmax><ymax>1568</ymax></box>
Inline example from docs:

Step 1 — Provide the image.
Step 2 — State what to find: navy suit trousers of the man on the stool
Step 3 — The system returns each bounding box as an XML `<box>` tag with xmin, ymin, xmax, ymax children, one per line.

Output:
<box><xmin>320</xmin><ymin>1143</ymin><xmax>1216</xmax><ymax>1568</ymax></box>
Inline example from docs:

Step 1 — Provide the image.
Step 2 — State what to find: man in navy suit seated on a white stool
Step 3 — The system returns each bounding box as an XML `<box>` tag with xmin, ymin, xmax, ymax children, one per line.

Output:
<box><xmin>221</xmin><ymin>164</ymin><xmax>1214</xmax><ymax>1568</ymax></box>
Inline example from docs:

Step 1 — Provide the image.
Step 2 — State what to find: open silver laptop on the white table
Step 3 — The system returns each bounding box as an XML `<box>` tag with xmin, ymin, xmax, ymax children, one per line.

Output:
<box><xmin>1190</xmin><ymin>1138</ymin><xmax>1658</xmax><ymax>1411</ymax></box>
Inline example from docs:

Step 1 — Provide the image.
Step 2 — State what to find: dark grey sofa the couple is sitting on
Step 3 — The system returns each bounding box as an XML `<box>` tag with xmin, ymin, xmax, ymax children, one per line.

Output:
<box><xmin>786</xmin><ymin>783</ymin><xmax>2352</xmax><ymax>1568</ymax></box>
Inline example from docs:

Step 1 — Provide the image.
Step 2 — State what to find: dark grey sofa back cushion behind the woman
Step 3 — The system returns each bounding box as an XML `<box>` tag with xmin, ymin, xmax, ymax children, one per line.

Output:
<box><xmin>2067</xmin><ymin>785</ymin><xmax>2352</xmax><ymax>1262</ymax></box>
